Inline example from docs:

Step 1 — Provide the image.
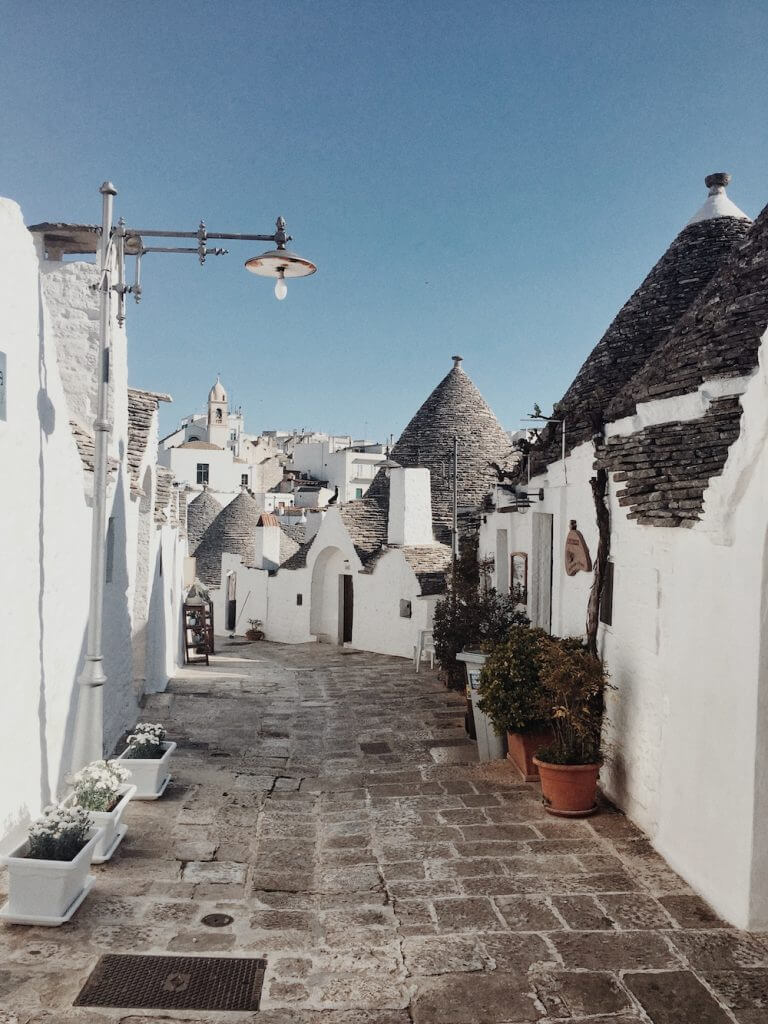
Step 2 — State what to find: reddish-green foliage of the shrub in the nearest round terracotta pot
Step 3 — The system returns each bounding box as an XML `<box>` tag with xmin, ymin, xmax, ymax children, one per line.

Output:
<box><xmin>537</xmin><ymin>636</ymin><xmax>608</xmax><ymax>765</ymax></box>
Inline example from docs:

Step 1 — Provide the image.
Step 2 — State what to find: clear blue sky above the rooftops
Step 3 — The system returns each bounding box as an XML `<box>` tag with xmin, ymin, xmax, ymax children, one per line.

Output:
<box><xmin>0</xmin><ymin>0</ymin><xmax>768</xmax><ymax>438</ymax></box>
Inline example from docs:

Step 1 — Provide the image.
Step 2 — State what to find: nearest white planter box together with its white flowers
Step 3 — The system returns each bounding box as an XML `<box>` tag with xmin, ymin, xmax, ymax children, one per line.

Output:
<box><xmin>0</xmin><ymin>806</ymin><xmax>101</xmax><ymax>926</ymax></box>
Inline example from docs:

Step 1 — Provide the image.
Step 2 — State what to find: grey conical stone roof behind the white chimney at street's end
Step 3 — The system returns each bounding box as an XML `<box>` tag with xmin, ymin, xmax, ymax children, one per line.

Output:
<box><xmin>368</xmin><ymin>355</ymin><xmax>512</xmax><ymax>540</ymax></box>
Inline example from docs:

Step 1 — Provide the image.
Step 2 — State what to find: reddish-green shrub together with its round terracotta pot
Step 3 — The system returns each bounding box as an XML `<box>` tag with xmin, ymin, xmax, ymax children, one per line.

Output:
<box><xmin>534</xmin><ymin>637</ymin><xmax>607</xmax><ymax>817</ymax></box>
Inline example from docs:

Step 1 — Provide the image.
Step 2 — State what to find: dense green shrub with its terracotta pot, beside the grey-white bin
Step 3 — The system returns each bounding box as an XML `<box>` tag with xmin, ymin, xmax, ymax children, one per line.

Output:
<box><xmin>478</xmin><ymin>626</ymin><xmax>552</xmax><ymax>782</ymax></box>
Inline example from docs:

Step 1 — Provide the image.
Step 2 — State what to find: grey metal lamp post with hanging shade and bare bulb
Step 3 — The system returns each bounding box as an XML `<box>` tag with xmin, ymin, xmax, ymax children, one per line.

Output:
<box><xmin>62</xmin><ymin>181</ymin><xmax>317</xmax><ymax>772</ymax></box>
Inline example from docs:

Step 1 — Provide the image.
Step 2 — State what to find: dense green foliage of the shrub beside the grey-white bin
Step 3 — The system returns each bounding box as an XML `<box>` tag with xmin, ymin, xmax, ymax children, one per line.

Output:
<box><xmin>477</xmin><ymin>626</ymin><xmax>548</xmax><ymax>733</ymax></box>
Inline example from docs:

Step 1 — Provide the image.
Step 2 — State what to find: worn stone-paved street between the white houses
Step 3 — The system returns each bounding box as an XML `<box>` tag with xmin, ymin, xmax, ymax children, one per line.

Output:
<box><xmin>0</xmin><ymin>640</ymin><xmax>768</xmax><ymax>1024</ymax></box>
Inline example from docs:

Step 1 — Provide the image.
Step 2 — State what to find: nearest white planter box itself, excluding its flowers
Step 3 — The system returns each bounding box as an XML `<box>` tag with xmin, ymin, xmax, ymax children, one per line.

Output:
<box><xmin>0</xmin><ymin>827</ymin><xmax>102</xmax><ymax>926</ymax></box>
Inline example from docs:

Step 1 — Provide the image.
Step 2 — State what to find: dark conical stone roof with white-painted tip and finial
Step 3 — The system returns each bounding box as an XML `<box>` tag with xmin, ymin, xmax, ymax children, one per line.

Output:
<box><xmin>530</xmin><ymin>174</ymin><xmax>752</xmax><ymax>472</ymax></box>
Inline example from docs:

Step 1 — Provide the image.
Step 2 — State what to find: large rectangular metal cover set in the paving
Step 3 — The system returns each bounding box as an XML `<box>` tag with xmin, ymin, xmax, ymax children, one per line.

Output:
<box><xmin>75</xmin><ymin>953</ymin><xmax>266</xmax><ymax>1010</ymax></box>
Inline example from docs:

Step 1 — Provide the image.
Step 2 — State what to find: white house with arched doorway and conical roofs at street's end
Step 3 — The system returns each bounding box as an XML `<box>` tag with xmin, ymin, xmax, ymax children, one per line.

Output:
<box><xmin>202</xmin><ymin>356</ymin><xmax>518</xmax><ymax>657</ymax></box>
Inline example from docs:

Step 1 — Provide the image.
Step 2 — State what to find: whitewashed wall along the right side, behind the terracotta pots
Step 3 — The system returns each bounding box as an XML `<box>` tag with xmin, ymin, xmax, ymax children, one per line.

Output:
<box><xmin>480</xmin><ymin>356</ymin><xmax>768</xmax><ymax>928</ymax></box>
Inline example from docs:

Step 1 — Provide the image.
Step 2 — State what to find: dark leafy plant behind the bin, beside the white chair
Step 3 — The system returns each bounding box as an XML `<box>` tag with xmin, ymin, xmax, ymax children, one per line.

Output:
<box><xmin>432</xmin><ymin>538</ymin><xmax>528</xmax><ymax>690</ymax></box>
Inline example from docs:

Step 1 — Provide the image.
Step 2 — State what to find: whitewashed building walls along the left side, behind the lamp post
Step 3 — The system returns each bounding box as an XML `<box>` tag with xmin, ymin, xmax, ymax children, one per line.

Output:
<box><xmin>0</xmin><ymin>199</ymin><xmax>183</xmax><ymax>846</ymax></box>
